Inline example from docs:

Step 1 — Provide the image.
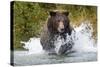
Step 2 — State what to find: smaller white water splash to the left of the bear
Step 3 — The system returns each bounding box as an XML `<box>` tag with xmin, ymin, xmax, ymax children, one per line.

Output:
<box><xmin>21</xmin><ymin>38</ymin><xmax>43</xmax><ymax>54</ymax></box>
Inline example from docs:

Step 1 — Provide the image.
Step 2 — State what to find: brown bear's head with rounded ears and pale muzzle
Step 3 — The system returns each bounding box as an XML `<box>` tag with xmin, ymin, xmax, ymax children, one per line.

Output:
<box><xmin>47</xmin><ymin>11</ymin><xmax>70</xmax><ymax>34</ymax></box>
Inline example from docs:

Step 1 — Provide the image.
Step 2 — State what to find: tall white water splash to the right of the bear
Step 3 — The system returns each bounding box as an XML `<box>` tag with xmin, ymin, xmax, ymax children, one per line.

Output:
<box><xmin>74</xmin><ymin>23</ymin><xmax>97</xmax><ymax>52</ymax></box>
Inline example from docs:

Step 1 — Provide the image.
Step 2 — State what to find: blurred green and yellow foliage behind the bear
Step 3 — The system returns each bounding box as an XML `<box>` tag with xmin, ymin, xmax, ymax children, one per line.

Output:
<box><xmin>12</xmin><ymin>1</ymin><xmax>97</xmax><ymax>49</ymax></box>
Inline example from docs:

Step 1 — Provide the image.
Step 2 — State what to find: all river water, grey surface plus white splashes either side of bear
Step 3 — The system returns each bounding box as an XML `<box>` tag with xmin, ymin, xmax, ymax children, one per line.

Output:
<box><xmin>14</xmin><ymin>23</ymin><xmax>97</xmax><ymax>66</ymax></box>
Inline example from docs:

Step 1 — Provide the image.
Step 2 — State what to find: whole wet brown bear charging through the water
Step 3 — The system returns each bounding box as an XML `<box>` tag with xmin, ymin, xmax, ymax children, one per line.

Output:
<box><xmin>40</xmin><ymin>11</ymin><xmax>73</xmax><ymax>54</ymax></box>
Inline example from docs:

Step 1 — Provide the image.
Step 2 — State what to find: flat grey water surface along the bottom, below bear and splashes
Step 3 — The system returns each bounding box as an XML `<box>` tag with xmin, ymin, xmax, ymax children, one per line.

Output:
<box><xmin>14</xmin><ymin>51</ymin><xmax>97</xmax><ymax>66</ymax></box>
